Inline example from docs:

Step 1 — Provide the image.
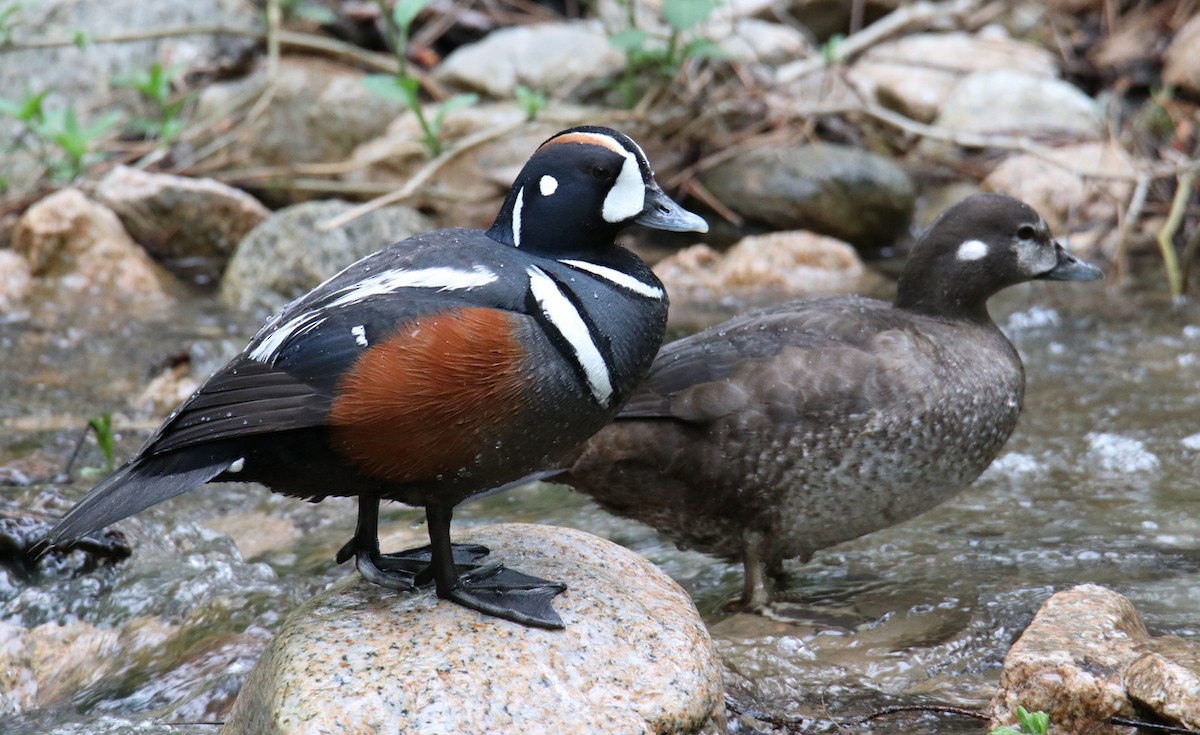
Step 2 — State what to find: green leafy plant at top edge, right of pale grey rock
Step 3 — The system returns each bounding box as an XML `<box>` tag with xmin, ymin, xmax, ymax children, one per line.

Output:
<box><xmin>608</xmin><ymin>0</ymin><xmax>725</xmax><ymax>106</ymax></box>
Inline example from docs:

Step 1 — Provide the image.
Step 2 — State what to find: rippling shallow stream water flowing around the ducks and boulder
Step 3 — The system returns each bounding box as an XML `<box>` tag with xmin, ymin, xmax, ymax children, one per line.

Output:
<box><xmin>0</xmin><ymin>272</ymin><xmax>1200</xmax><ymax>734</ymax></box>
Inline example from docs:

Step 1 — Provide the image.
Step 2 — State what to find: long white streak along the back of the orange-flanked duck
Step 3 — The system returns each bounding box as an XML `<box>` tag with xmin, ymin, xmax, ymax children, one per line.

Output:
<box><xmin>247</xmin><ymin>265</ymin><xmax>497</xmax><ymax>365</ymax></box>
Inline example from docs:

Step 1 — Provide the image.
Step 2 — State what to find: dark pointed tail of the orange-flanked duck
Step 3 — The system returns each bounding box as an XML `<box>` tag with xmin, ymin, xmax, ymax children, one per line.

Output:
<box><xmin>46</xmin><ymin>452</ymin><xmax>233</xmax><ymax>545</ymax></box>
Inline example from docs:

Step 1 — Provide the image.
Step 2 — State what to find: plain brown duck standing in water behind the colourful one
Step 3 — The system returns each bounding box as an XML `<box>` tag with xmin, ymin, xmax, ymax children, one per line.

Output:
<box><xmin>554</xmin><ymin>195</ymin><xmax>1102</xmax><ymax>609</ymax></box>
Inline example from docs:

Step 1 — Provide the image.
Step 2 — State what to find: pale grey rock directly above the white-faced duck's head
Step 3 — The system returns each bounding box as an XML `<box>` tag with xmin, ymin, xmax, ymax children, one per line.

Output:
<box><xmin>437</xmin><ymin>22</ymin><xmax>625</xmax><ymax>98</ymax></box>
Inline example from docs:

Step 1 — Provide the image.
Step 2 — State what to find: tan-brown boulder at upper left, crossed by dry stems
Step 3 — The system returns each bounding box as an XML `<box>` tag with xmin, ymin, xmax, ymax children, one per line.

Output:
<box><xmin>196</xmin><ymin>56</ymin><xmax>404</xmax><ymax>166</ymax></box>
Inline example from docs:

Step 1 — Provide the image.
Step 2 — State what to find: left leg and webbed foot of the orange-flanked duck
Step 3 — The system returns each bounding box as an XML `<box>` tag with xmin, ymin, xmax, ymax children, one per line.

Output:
<box><xmin>336</xmin><ymin>497</ymin><xmax>487</xmax><ymax>592</ymax></box>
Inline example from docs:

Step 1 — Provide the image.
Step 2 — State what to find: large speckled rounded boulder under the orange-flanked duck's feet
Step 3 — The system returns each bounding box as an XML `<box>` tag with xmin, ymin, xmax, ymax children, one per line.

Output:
<box><xmin>222</xmin><ymin>525</ymin><xmax>722</xmax><ymax>735</ymax></box>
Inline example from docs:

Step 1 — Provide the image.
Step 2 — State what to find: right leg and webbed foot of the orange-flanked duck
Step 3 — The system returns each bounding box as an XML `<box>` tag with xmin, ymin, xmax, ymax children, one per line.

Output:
<box><xmin>425</xmin><ymin>506</ymin><xmax>566</xmax><ymax>629</ymax></box>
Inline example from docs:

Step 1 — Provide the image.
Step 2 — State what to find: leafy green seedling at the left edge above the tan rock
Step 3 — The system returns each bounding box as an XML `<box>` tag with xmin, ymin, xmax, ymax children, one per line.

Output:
<box><xmin>0</xmin><ymin>91</ymin><xmax>120</xmax><ymax>180</ymax></box>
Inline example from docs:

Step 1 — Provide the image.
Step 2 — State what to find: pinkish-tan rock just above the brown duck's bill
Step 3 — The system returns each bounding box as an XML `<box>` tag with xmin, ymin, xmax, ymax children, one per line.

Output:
<box><xmin>983</xmin><ymin>143</ymin><xmax>1136</xmax><ymax>243</ymax></box>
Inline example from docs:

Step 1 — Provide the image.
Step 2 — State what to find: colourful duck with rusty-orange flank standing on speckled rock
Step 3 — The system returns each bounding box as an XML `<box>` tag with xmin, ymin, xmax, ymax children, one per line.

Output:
<box><xmin>47</xmin><ymin>127</ymin><xmax>707</xmax><ymax>628</ymax></box>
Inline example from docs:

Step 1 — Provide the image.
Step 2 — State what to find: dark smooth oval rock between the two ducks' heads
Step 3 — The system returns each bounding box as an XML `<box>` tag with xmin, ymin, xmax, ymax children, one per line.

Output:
<box><xmin>702</xmin><ymin>144</ymin><xmax>916</xmax><ymax>249</ymax></box>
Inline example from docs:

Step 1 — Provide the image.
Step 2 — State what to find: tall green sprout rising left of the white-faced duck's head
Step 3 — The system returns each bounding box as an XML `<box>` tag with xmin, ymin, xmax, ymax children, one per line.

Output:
<box><xmin>362</xmin><ymin>0</ymin><xmax>479</xmax><ymax>156</ymax></box>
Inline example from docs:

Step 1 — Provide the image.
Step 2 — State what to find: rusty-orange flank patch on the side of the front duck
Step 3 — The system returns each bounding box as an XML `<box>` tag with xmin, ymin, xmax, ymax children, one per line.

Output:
<box><xmin>328</xmin><ymin>309</ymin><xmax>527</xmax><ymax>482</ymax></box>
